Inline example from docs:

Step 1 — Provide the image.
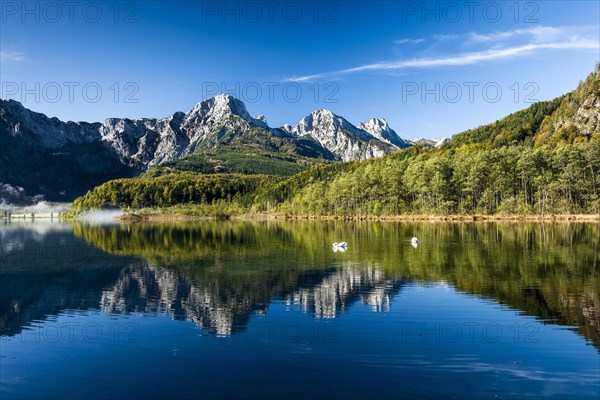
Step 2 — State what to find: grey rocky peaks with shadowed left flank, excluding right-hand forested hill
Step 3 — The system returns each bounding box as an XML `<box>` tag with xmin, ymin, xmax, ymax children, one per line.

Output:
<box><xmin>0</xmin><ymin>95</ymin><xmax>422</xmax><ymax>201</ymax></box>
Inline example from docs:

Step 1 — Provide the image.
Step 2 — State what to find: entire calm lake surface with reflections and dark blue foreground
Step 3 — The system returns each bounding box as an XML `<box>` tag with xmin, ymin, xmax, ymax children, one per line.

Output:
<box><xmin>0</xmin><ymin>222</ymin><xmax>600</xmax><ymax>400</ymax></box>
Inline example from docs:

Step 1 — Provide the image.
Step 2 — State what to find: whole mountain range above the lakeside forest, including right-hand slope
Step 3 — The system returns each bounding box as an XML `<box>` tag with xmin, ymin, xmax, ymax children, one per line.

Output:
<box><xmin>7</xmin><ymin>65</ymin><xmax>600</xmax><ymax>204</ymax></box>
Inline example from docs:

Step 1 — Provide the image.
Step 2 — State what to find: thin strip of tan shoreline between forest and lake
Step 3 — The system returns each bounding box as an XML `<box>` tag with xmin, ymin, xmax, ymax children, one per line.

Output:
<box><xmin>116</xmin><ymin>213</ymin><xmax>600</xmax><ymax>223</ymax></box>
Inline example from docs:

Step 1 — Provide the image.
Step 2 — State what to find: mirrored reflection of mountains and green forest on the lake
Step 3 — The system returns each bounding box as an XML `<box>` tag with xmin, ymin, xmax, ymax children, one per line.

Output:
<box><xmin>0</xmin><ymin>222</ymin><xmax>600</xmax><ymax>349</ymax></box>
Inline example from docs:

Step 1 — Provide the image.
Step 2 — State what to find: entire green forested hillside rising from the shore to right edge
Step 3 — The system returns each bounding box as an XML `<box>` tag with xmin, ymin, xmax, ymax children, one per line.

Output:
<box><xmin>75</xmin><ymin>66</ymin><xmax>600</xmax><ymax>216</ymax></box>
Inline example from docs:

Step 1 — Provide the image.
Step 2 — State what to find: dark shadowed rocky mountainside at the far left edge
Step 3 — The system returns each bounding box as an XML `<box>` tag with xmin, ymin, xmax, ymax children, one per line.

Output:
<box><xmin>0</xmin><ymin>100</ymin><xmax>141</xmax><ymax>203</ymax></box>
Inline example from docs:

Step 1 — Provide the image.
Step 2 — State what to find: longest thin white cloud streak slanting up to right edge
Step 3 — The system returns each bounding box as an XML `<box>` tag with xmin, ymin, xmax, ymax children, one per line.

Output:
<box><xmin>287</xmin><ymin>39</ymin><xmax>600</xmax><ymax>82</ymax></box>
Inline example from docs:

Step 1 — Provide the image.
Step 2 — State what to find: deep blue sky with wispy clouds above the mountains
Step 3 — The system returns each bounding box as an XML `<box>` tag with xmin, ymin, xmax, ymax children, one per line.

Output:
<box><xmin>0</xmin><ymin>0</ymin><xmax>600</xmax><ymax>139</ymax></box>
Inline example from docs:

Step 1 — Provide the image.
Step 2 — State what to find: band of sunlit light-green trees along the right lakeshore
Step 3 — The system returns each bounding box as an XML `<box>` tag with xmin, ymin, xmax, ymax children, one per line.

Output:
<box><xmin>264</xmin><ymin>139</ymin><xmax>600</xmax><ymax>215</ymax></box>
